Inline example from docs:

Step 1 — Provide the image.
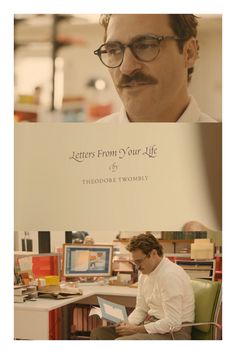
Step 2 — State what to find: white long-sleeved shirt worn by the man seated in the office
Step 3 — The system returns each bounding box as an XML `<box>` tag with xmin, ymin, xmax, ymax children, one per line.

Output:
<box><xmin>128</xmin><ymin>257</ymin><xmax>194</xmax><ymax>334</ymax></box>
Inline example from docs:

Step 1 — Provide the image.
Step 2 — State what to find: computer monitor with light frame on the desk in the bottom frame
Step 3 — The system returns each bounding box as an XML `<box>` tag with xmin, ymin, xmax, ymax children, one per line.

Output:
<box><xmin>63</xmin><ymin>243</ymin><xmax>113</xmax><ymax>278</ymax></box>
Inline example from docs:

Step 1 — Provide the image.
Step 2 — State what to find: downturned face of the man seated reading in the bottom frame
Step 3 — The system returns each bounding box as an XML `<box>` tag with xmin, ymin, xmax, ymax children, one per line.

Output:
<box><xmin>132</xmin><ymin>249</ymin><xmax>160</xmax><ymax>274</ymax></box>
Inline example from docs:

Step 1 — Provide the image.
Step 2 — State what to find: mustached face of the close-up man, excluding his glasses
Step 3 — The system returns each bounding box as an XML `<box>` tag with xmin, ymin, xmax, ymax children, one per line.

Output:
<box><xmin>106</xmin><ymin>14</ymin><xmax>195</xmax><ymax>122</ymax></box>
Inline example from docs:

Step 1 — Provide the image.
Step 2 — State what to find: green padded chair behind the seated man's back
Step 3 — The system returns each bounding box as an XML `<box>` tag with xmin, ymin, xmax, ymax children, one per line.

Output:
<box><xmin>191</xmin><ymin>279</ymin><xmax>221</xmax><ymax>339</ymax></box>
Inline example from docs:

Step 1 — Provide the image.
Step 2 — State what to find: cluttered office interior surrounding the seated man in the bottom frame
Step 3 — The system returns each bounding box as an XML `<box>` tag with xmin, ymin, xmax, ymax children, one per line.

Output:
<box><xmin>14</xmin><ymin>230</ymin><xmax>222</xmax><ymax>340</ymax></box>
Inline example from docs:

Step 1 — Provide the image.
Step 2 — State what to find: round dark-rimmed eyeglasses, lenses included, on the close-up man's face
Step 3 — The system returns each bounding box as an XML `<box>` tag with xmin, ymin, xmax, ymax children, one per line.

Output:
<box><xmin>94</xmin><ymin>35</ymin><xmax>182</xmax><ymax>69</ymax></box>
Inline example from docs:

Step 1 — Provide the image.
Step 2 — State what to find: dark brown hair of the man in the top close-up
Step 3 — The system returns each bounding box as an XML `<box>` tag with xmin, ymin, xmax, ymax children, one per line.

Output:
<box><xmin>100</xmin><ymin>14</ymin><xmax>199</xmax><ymax>82</ymax></box>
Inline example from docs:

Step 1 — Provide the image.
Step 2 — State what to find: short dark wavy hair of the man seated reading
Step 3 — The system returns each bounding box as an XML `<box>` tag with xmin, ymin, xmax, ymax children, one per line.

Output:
<box><xmin>126</xmin><ymin>232</ymin><xmax>163</xmax><ymax>257</ymax></box>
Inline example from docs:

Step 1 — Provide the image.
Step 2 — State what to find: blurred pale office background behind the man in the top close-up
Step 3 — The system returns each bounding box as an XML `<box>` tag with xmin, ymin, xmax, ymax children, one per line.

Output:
<box><xmin>14</xmin><ymin>14</ymin><xmax>222</xmax><ymax>122</ymax></box>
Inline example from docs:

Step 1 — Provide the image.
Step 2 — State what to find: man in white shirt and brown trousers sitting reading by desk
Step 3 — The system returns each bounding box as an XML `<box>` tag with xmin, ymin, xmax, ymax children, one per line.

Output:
<box><xmin>90</xmin><ymin>234</ymin><xmax>194</xmax><ymax>340</ymax></box>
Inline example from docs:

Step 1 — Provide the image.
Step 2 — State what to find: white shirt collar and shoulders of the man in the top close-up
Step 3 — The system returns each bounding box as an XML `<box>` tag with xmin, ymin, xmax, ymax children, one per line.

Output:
<box><xmin>98</xmin><ymin>96</ymin><xmax>217</xmax><ymax>123</ymax></box>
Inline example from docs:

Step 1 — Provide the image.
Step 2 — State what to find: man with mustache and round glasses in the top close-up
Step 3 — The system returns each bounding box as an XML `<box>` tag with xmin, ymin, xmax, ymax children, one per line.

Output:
<box><xmin>94</xmin><ymin>14</ymin><xmax>215</xmax><ymax>123</ymax></box>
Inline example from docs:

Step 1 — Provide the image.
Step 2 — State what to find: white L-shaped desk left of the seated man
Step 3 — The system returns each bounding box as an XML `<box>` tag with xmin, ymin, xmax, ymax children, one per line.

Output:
<box><xmin>14</xmin><ymin>285</ymin><xmax>137</xmax><ymax>339</ymax></box>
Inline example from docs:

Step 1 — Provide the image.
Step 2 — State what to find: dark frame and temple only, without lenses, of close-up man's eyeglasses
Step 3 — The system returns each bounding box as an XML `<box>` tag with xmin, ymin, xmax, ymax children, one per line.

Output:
<box><xmin>93</xmin><ymin>35</ymin><xmax>184</xmax><ymax>69</ymax></box>
